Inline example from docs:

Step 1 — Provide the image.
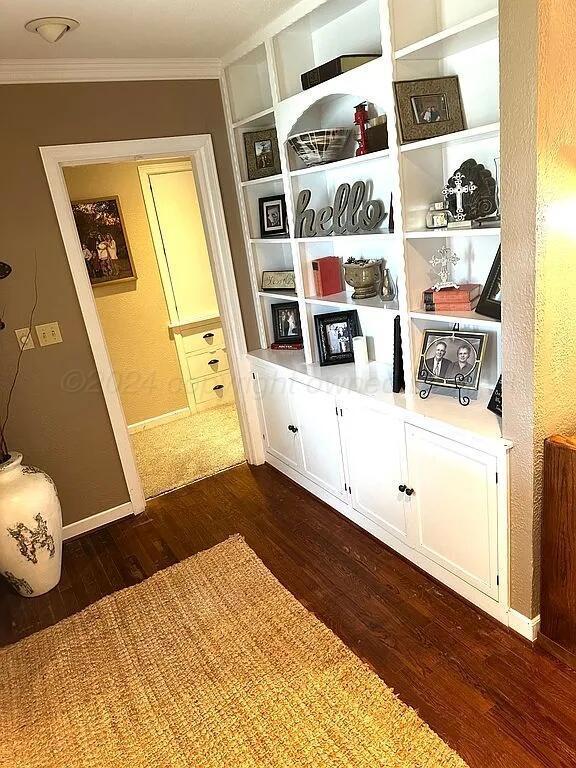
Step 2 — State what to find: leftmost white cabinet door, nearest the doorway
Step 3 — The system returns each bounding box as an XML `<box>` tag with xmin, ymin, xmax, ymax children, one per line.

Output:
<box><xmin>256</xmin><ymin>372</ymin><xmax>298</xmax><ymax>469</ymax></box>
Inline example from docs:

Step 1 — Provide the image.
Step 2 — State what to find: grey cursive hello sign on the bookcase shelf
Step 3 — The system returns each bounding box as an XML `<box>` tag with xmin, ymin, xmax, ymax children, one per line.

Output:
<box><xmin>295</xmin><ymin>181</ymin><xmax>388</xmax><ymax>237</ymax></box>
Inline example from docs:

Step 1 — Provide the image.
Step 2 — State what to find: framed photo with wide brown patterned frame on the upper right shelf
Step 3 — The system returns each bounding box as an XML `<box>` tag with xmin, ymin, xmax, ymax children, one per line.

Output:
<box><xmin>394</xmin><ymin>75</ymin><xmax>465</xmax><ymax>144</ymax></box>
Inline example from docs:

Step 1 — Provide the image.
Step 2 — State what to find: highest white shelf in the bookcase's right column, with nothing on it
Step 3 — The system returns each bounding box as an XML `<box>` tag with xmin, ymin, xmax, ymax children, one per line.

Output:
<box><xmin>394</xmin><ymin>9</ymin><xmax>498</xmax><ymax>60</ymax></box>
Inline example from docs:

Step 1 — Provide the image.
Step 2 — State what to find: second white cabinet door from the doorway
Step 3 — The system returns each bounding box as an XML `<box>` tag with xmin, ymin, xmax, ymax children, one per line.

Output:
<box><xmin>290</xmin><ymin>381</ymin><xmax>345</xmax><ymax>497</ymax></box>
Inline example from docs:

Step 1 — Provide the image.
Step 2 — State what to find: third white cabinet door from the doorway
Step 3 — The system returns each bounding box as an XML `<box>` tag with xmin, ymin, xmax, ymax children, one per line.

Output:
<box><xmin>342</xmin><ymin>406</ymin><xmax>410</xmax><ymax>543</ymax></box>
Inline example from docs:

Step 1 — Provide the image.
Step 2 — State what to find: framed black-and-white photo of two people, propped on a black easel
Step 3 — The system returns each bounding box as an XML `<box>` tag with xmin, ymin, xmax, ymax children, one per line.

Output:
<box><xmin>416</xmin><ymin>330</ymin><xmax>487</xmax><ymax>389</ymax></box>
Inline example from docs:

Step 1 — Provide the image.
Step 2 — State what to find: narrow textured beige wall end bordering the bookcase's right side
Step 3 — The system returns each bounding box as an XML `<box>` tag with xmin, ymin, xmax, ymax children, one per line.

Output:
<box><xmin>500</xmin><ymin>0</ymin><xmax>539</xmax><ymax>616</ymax></box>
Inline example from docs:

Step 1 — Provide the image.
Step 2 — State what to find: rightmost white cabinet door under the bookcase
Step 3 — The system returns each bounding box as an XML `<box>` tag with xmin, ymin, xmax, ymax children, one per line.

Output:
<box><xmin>406</xmin><ymin>424</ymin><xmax>498</xmax><ymax>598</ymax></box>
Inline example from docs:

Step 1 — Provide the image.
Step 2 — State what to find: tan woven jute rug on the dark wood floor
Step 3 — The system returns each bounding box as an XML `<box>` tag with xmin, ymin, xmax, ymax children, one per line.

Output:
<box><xmin>0</xmin><ymin>536</ymin><xmax>465</xmax><ymax>768</ymax></box>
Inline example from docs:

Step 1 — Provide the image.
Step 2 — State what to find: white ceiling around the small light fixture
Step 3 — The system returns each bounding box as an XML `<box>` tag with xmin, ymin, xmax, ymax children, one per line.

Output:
<box><xmin>0</xmin><ymin>0</ymin><xmax>291</xmax><ymax>60</ymax></box>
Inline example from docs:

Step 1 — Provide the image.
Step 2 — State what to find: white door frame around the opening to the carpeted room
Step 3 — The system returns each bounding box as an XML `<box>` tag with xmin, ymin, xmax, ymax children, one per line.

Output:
<box><xmin>40</xmin><ymin>134</ymin><xmax>263</xmax><ymax>514</ymax></box>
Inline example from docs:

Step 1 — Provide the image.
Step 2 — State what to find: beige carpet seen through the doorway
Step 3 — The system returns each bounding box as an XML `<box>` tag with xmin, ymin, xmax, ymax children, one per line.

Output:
<box><xmin>132</xmin><ymin>403</ymin><xmax>245</xmax><ymax>499</ymax></box>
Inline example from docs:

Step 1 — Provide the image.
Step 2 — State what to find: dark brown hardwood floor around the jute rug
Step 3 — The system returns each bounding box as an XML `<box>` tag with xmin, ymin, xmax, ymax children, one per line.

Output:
<box><xmin>0</xmin><ymin>465</ymin><xmax>576</xmax><ymax>768</ymax></box>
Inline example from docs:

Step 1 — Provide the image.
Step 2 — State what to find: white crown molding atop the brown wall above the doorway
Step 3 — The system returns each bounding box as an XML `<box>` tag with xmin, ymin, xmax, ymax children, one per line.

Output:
<box><xmin>0</xmin><ymin>59</ymin><xmax>222</xmax><ymax>85</ymax></box>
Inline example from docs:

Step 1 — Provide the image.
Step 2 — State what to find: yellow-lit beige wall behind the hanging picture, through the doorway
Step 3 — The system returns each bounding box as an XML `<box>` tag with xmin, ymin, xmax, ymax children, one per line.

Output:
<box><xmin>64</xmin><ymin>163</ymin><xmax>188</xmax><ymax>424</ymax></box>
